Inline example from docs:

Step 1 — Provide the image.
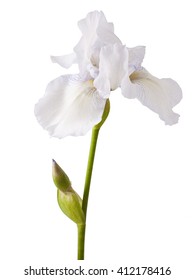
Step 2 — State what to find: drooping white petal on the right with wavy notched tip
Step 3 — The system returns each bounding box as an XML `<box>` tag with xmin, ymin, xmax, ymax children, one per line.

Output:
<box><xmin>121</xmin><ymin>69</ymin><xmax>182</xmax><ymax>125</ymax></box>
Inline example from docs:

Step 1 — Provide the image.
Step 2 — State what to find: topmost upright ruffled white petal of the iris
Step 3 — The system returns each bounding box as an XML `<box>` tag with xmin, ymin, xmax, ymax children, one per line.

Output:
<box><xmin>74</xmin><ymin>11</ymin><xmax>120</xmax><ymax>74</ymax></box>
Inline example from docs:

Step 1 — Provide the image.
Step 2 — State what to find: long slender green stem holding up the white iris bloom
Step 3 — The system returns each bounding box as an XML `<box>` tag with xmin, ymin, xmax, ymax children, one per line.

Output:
<box><xmin>78</xmin><ymin>100</ymin><xmax>110</xmax><ymax>260</ymax></box>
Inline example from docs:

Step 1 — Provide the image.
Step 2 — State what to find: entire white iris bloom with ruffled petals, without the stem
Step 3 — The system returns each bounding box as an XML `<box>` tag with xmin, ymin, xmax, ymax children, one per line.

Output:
<box><xmin>35</xmin><ymin>11</ymin><xmax>182</xmax><ymax>138</ymax></box>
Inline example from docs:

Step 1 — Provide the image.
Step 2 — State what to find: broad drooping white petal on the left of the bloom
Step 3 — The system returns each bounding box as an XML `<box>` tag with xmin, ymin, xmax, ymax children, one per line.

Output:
<box><xmin>35</xmin><ymin>75</ymin><xmax>106</xmax><ymax>138</ymax></box>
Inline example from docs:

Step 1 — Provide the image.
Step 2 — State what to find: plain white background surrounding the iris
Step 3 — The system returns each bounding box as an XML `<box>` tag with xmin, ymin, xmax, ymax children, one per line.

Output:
<box><xmin>0</xmin><ymin>0</ymin><xmax>194</xmax><ymax>280</ymax></box>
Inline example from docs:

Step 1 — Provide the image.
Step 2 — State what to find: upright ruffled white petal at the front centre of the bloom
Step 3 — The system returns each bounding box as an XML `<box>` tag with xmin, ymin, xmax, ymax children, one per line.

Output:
<box><xmin>94</xmin><ymin>44</ymin><xmax>128</xmax><ymax>98</ymax></box>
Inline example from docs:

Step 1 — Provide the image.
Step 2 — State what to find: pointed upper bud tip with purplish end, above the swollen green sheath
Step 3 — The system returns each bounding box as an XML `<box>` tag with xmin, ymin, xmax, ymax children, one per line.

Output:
<box><xmin>52</xmin><ymin>159</ymin><xmax>71</xmax><ymax>192</ymax></box>
